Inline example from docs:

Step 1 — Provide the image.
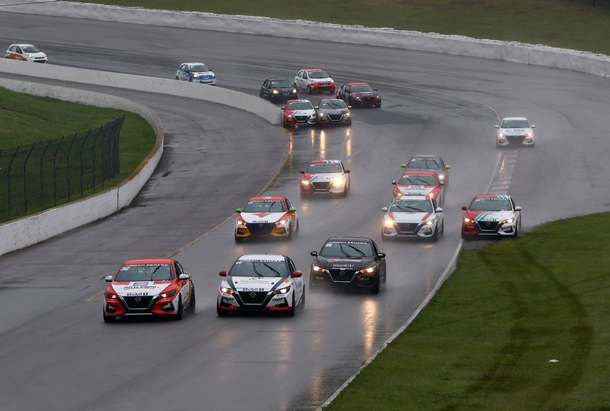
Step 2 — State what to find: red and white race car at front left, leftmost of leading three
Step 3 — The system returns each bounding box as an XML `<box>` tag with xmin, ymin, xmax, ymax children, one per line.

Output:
<box><xmin>102</xmin><ymin>258</ymin><xmax>196</xmax><ymax>322</ymax></box>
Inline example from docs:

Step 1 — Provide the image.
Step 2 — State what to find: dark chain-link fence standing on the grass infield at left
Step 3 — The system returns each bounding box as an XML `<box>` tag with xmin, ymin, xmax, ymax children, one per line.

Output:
<box><xmin>0</xmin><ymin>116</ymin><xmax>125</xmax><ymax>222</ymax></box>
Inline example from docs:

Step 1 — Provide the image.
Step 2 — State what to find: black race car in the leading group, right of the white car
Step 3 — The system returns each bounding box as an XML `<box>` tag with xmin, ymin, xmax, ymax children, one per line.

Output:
<box><xmin>309</xmin><ymin>237</ymin><xmax>387</xmax><ymax>294</ymax></box>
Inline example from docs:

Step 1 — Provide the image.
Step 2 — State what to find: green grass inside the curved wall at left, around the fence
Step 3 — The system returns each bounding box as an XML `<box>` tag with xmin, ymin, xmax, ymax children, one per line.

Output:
<box><xmin>0</xmin><ymin>88</ymin><xmax>156</xmax><ymax>222</ymax></box>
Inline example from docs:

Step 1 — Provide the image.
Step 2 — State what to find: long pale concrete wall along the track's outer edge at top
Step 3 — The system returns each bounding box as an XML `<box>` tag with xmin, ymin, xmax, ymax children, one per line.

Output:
<box><xmin>3</xmin><ymin>1</ymin><xmax>610</xmax><ymax>78</ymax></box>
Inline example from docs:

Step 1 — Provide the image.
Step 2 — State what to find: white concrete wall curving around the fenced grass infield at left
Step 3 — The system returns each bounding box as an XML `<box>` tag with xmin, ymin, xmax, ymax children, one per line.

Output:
<box><xmin>0</xmin><ymin>77</ymin><xmax>164</xmax><ymax>255</ymax></box>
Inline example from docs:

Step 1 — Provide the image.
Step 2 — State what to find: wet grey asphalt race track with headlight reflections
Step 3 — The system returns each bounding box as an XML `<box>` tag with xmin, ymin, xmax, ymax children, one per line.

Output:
<box><xmin>0</xmin><ymin>11</ymin><xmax>610</xmax><ymax>411</ymax></box>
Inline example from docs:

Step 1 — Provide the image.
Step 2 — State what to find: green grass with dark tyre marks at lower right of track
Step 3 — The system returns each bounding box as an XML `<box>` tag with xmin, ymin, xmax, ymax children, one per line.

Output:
<box><xmin>325</xmin><ymin>213</ymin><xmax>610</xmax><ymax>411</ymax></box>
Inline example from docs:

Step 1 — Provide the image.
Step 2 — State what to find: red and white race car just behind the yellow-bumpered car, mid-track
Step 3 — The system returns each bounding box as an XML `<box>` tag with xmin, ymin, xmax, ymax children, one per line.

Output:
<box><xmin>301</xmin><ymin>160</ymin><xmax>351</xmax><ymax>198</ymax></box>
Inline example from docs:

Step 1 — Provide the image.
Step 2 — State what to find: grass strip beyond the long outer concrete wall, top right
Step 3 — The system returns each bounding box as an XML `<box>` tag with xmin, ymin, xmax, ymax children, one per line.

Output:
<box><xmin>72</xmin><ymin>0</ymin><xmax>610</xmax><ymax>55</ymax></box>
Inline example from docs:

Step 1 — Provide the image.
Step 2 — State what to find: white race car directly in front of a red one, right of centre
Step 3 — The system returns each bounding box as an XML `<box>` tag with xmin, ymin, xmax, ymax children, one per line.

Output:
<box><xmin>381</xmin><ymin>196</ymin><xmax>445</xmax><ymax>241</ymax></box>
